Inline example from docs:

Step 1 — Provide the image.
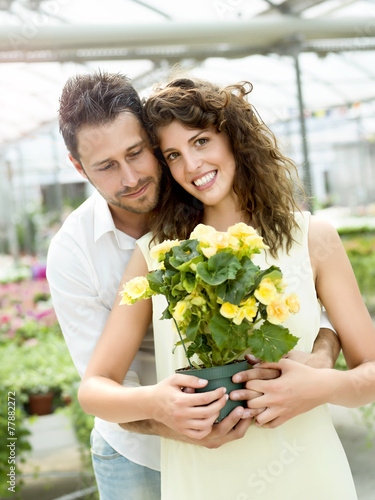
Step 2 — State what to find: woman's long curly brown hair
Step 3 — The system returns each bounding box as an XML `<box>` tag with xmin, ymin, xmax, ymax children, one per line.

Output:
<box><xmin>144</xmin><ymin>78</ymin><xmax>306</xmax><ymax>256</ymax></box>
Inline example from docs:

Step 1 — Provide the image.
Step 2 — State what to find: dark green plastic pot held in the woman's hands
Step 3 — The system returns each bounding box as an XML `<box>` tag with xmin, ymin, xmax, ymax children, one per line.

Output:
<box><xmin>176</xmin><ymin>360</ymin><xmax>248</xmax><ymax>422</ymax></box>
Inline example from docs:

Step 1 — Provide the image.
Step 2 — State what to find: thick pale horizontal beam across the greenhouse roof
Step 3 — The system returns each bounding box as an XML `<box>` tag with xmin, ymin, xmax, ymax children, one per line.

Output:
<box><xmin>0</xmin><ymin>16</ymin><xmax>375</xmax><ymax>62</ymax></box>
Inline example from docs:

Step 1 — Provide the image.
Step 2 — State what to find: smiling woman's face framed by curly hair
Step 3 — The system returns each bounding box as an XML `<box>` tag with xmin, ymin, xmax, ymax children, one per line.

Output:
<box><xmin>159</xmin><ymin>120</ymin><xmax>236</xmax><ymax>210</ymax></box>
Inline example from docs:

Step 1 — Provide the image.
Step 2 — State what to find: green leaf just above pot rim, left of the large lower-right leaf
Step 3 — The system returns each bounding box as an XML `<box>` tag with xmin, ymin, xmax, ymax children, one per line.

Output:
<box><xmin>208</xmin><ymin>313</ymin><xmax>249</xmax><ymax>351</ymax></box>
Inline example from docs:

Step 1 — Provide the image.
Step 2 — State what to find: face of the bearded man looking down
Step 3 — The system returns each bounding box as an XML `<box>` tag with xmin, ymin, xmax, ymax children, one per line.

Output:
<box><xmin>73</xmin><ymin>111</ymin><xmax>161</xmax><ymax>214</ymax></box>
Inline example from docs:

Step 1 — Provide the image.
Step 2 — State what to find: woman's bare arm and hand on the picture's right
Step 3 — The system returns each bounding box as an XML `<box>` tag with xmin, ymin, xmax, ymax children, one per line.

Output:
<box><xmin>245</xmin><ymin>217</ymin><xmax>375</xmax><ymax>427</ymax></box>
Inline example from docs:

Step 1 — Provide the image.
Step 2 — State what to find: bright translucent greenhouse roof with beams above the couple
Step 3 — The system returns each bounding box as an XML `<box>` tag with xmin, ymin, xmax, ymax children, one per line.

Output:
<box><xmin>0</xmin><ymin>0</ymin><xmax>375</xmax><ymax>146</ymax></box>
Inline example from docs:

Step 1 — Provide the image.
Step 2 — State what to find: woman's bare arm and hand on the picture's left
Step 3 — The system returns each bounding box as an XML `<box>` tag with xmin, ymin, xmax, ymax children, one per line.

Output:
<box><xmin>78</xmin><ymin>249</ymin><xmax>227</xmax><ymax>438</ymax></box>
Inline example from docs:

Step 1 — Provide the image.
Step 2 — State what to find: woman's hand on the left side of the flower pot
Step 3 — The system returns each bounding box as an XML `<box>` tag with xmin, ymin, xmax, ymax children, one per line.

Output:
<box><xmin>150</xmin><ymin>374</ymin><xmax>228</xmax><ymax>440</ymax></box>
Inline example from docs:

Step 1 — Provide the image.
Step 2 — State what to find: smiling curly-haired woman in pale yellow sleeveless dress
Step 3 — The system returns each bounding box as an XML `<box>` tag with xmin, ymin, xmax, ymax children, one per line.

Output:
<box><xmin>79</xmin><ymin>79</ymin><xmax>375</xmax><ymax>500</ymax></box>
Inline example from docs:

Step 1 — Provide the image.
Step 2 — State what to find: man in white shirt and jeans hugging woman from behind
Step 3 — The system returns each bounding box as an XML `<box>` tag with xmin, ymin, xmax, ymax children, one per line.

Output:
<box><xmin>47</xmin><ymin>73</ymin><xmax>335</xmax><ymax>500</ymax></box>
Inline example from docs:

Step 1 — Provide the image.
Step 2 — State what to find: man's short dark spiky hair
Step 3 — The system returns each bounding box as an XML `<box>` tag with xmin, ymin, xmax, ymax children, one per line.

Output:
<box><xmin>59</xmin><ymin>71</ymin><xmax>142</xmax><ymax>161</ymax></box>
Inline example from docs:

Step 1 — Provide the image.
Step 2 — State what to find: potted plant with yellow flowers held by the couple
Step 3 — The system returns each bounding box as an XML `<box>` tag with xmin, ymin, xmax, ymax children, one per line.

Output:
<box><xmin>120</xmin><ymin>223</ymin><xmax>299</xmax><ymax>420</ymax></box>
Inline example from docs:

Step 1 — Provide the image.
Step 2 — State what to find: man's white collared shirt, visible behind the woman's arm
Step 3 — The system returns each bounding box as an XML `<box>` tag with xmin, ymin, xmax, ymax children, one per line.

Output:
<box><xmin>47</xmin><ymin>192</ymin><xmax>160</xmax><ymax>470</ymax></box>
